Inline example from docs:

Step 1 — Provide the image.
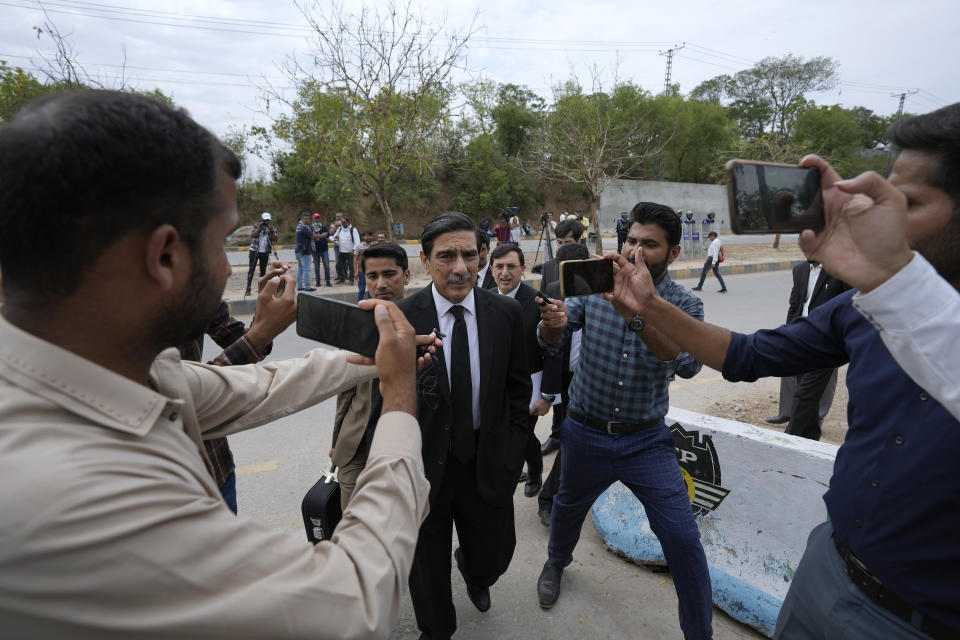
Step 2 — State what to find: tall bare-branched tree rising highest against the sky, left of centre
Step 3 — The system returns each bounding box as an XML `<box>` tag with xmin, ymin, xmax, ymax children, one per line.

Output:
<box><xmin>265</xmin><ymin>0</ymin><xmax>474</xmax><ymax>238</ymax></box>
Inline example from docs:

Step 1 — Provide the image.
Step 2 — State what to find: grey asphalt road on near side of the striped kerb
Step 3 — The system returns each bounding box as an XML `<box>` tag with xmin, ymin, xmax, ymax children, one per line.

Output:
<box><xmin>219</xmin><ymin>271</ymin><xmax>791</xmax><ymax>640</ymax></box>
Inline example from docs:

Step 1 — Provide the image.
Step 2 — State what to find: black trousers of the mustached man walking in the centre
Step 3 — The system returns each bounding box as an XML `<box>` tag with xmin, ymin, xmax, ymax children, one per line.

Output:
<box><xmin>410</xmin><ymin>454</ymin><xmax>517</xmax><ymax>639</ymax></box>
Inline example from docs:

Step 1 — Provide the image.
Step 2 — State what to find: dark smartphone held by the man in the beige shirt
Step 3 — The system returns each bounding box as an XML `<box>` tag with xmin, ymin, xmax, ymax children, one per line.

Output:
<box><xmin>297</xmin><ymin>293</ymin><xmax>380</xmax><ymax>358</ymax></box>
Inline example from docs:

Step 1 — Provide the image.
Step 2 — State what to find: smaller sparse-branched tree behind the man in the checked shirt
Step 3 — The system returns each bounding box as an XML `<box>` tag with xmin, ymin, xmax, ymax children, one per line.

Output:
<box><xmin>520</xmin><ymin>70</ymin><xmax>671</xmax><ymax>254</ymax></box>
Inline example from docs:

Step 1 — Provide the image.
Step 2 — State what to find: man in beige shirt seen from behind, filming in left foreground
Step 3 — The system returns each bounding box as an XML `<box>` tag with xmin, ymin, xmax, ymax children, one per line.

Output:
<box><xmin>0</xmin><ymin>90</ymin><xmax>428</xmax><ymax>640</ymax></box>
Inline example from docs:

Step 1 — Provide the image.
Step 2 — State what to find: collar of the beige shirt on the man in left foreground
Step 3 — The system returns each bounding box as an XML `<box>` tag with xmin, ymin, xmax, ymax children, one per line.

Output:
<box><xmin>0</xmin><ymin>316</ymin><xmax>174</xmax><ymax>435</ymax></box>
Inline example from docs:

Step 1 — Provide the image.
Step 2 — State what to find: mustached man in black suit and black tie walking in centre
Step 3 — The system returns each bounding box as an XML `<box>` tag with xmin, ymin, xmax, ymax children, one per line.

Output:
<box><xmin>397</xmin><ymin>212</ymin><xmax>532</xmax><ymax>638</ymax></box>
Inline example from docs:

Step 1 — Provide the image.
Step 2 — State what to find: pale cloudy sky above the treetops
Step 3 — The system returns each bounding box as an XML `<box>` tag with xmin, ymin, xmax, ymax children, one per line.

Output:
<box><xmin>0</xmin><ymin>0</ymin><xmax>960</xmax><ymax>149</ymax></box>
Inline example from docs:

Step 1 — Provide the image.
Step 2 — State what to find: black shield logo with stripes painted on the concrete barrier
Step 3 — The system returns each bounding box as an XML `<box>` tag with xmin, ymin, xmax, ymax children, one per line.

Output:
<box><xmin>670</xmin><ymin>423</ymin><xmax>730</xmax><ymax>516</ymax></box>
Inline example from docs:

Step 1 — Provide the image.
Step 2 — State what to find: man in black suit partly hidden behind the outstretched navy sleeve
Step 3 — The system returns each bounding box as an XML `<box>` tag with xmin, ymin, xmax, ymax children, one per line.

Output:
<box><xmin>767</xmin><ymin>261</ymin><xmax>850</xmax><ymax>440</ymax></box>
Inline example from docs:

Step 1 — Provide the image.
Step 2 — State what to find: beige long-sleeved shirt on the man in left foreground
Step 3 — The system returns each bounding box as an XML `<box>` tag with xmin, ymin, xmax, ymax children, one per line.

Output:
<box><xmin>0</xmin><ymin>318</ymin><xmax>429</xmax><ymax>638</ymax></box>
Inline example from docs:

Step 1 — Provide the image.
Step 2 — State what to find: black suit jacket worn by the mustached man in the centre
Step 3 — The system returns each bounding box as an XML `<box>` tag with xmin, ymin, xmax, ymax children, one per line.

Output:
<box><xmin>386</xmin><ymin>284</ymin><xmax>532</xmax><ymax>505</ymax></box>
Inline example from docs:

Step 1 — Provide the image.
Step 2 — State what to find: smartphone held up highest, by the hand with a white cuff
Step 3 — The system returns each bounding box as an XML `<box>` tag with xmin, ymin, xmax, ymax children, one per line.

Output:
<box><xmin>726</xmin><ymin>160</ymin><xmax>825</xmax><ymax>234</ymax></box>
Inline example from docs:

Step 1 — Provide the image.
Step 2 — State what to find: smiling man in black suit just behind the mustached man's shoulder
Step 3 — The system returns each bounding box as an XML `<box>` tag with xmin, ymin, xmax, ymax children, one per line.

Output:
<box><xmin>490</xmin><ymin>244</ymin><xmax>554</xmax><ymax>498</ymax></box>
